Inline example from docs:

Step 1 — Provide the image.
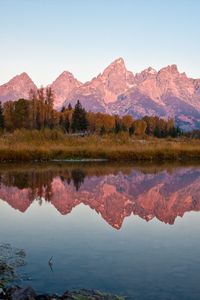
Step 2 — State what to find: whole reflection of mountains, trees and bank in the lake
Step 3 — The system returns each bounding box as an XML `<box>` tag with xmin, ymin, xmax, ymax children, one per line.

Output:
<box><xmin>0</xmin><ymin>165</ymin><xmax>200</xmax><ymax>229</ymax></box>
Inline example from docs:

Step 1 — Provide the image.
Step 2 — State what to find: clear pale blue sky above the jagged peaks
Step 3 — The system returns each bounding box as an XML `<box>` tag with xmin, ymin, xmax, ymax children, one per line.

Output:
<box><xmin>0</xmin><ymin>0</ymin><xmax>200</xmax><ymax>85</ymax></box>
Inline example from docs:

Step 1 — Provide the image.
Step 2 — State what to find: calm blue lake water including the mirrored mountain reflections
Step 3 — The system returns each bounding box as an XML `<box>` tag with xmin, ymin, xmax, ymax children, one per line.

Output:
<box><xmin>0</xmin><ymin>163</ymin><xmax>200</xmax><ymax>300</ymax></box>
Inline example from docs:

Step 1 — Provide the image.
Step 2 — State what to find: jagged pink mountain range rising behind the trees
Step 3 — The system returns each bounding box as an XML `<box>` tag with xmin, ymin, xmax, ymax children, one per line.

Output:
<box><xmin>0</xmin><ymin>58</ymin><xmax>200</xmax><ymax>130</ymax></box>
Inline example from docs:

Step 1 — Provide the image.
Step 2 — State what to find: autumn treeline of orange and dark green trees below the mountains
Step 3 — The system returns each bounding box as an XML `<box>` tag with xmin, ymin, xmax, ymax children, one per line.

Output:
<box><xmin>0</xmin><ymin>87</ymin><xmax>181</xmax><ymax>138</ymax></box>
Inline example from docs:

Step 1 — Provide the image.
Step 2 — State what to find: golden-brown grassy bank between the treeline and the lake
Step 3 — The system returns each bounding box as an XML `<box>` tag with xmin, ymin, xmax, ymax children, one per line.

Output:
<box><xmin>0</xmin><ymin>130</ymin><xmax>200</xmax><ymax>162</ymax></box>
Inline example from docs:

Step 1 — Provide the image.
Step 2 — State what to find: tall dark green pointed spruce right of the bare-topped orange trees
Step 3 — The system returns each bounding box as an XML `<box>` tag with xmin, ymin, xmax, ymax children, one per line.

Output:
<box><xmin>71</xmin><ymin>100</ymin><xmax>88</xmax><ymax>132</ymax></box>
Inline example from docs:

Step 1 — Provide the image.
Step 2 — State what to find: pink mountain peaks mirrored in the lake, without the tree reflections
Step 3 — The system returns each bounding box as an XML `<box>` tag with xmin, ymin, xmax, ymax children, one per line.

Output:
<box><xmin>0</xmin><ymin>169</ymin><xmax>200</xmax><ymax>229</ymax></box>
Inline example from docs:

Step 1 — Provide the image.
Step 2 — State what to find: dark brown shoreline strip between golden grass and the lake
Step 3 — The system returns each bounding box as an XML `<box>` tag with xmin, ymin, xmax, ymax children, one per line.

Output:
<box><xmin>0</xmin><ymin>148</ymin><xmax>200</xmax><ymax>164</ymax></box>
